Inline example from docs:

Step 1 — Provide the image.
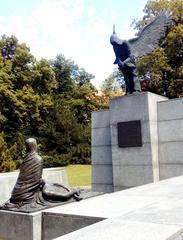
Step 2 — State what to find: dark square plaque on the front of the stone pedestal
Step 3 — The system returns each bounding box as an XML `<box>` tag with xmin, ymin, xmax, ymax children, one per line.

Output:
<box><xmin>117</xmin><ymin>120</ymin><xmax>142</xmax><ymax>148</ymax></box>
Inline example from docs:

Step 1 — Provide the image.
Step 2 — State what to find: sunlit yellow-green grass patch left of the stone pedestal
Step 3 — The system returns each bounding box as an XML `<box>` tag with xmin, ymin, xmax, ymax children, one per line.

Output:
<box><xmin>65</xmin><ymin>165</ymin><xmax>91</xmax><ymax>187</ymax></box>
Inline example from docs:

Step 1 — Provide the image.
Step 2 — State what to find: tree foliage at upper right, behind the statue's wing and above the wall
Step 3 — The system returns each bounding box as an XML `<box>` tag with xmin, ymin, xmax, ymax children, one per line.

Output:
<box><xmin>134</xmin><ymin>0</ymin><xmax>183</xmax><ymax>98</ymax></box>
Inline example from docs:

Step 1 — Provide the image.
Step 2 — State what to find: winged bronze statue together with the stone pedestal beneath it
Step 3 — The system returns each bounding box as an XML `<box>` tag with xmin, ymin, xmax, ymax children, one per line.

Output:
<box><xmin>92</xmin><ymin>11</ymin><xmax>174</xmax><ymax>192</ymax></box>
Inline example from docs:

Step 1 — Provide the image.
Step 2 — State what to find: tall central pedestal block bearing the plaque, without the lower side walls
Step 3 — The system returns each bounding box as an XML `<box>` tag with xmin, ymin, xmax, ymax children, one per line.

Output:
<box><xmin>110</xmin><ymin>92</ymin><xmax>165</xmax><ymax>190</ymax></box>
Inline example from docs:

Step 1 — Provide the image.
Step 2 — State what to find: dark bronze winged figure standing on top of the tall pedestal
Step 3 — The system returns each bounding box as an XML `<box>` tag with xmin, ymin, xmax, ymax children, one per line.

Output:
<box><xmin>110</xmin><ymin>11</ymin><xmax>171</xmax><ymax>94</ymax></box>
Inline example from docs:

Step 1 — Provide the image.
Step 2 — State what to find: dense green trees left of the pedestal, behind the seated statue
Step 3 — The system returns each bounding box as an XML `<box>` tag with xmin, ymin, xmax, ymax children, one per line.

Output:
<box><xmin>0</xmin><ymin>36</ymin><xmax>106</xmax><ymax>171</ymax></box>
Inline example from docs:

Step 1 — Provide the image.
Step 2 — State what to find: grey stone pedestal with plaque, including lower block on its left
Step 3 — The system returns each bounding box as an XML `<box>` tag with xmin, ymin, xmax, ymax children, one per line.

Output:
<box><xmin>92</xmin><ymin>92</ymin><xmax>166</xmax><ymax>192</ymax></box>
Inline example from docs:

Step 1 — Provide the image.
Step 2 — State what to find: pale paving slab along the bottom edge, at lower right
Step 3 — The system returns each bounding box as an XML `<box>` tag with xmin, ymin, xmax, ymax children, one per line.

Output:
<box><xmin>55</xmin><ymin>219</ymin><xmax>182</xmax><ymax>240</ymax></box>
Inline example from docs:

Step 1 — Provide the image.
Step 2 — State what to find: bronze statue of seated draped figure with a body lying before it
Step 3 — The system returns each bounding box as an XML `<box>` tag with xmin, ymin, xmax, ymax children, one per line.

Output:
<box><xmin>0</xmin><ymin>138</ymin><xmax>81</xmax><ymax>210</ymax></box>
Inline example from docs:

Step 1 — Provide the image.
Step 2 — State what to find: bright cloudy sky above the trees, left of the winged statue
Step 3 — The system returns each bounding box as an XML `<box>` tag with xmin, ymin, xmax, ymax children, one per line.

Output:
<box><xmin>0</xmin><ymin>0</ymin><xmax>147</xmax><ymax>88</ymax></box>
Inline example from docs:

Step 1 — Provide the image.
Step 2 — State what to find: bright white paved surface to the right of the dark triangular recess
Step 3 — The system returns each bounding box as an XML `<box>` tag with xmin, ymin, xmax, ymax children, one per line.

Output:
<box><xmin>43</xmin><ymin>176</ymin><xmax>183</xmax><ymax>240</ymax></box>
